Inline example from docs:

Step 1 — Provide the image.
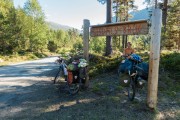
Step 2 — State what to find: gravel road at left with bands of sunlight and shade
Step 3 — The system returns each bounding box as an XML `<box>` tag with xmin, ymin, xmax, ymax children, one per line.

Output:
<box><xmin>0</xmin><ymin>57</ymin><xmax>58</xmax><ymax>119</ymax></box>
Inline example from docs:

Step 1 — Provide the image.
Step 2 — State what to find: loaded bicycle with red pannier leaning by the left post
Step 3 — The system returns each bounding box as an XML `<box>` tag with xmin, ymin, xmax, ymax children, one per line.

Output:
<box><xmin>54</xmin><ymin>58</ymin><xmax>88</xmax><ymax>95</ymax></box>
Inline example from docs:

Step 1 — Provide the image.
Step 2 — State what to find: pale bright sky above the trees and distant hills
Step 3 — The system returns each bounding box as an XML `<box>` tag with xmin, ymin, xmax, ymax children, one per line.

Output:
<box><xmin>14</xmin><ymin>0</ymin><xmax>146</xmax><ymax>30</ymax></box>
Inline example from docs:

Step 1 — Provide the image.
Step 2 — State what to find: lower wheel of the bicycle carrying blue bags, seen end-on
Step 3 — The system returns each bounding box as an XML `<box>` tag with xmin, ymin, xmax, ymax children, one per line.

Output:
<box><xmin>128</xmin><ymin>78</ymin><xmax>136</xmax><ymax>101</ymax></box>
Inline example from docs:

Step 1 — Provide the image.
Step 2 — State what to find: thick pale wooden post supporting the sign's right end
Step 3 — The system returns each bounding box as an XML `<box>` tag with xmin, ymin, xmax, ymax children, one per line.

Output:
<box><xmin>147</xmin><ymin>8</ymin><xmax>162</xmax><ymax>109</ymax></box>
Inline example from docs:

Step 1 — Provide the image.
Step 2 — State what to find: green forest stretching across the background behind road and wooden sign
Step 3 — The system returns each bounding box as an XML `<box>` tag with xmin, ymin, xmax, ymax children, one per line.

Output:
<box><xmin>0</xmin><ymin>0</ymin><xmax>180</xmax><ymax>66</ymax></box>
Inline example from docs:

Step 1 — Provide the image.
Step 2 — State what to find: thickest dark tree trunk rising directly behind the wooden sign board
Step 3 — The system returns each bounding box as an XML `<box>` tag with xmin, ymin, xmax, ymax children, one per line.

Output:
<box><xmin>105</xmin><ymin>0</ymin><xmax>112</xmax><ymax>56</ymax></box>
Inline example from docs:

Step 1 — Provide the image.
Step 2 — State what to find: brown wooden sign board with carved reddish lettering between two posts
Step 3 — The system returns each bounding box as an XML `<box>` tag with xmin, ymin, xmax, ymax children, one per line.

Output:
<box><xmin>90</xmin><ymin>20</ymin><xmax>148</xmax><ymax>37</ymax></box>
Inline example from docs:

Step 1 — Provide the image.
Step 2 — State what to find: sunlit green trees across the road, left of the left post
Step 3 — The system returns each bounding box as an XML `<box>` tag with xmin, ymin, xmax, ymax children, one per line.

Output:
<box><xmin>0</xmin><ymin>0</ymin><xmax>82</xmax><ymax>55</ymax></box>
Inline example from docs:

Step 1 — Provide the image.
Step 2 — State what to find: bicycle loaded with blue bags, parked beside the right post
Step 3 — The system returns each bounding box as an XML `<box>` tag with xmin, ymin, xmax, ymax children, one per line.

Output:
<box><xmin>118</xmin><ymin>54</ymin><xmax>149</xmax><ymax>101</ymax></box>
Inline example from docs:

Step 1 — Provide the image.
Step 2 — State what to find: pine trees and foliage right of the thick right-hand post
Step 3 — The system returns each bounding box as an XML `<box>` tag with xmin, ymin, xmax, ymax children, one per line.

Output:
<box><xmin>163</xmin><ymin>0</ymin><xmax>180</xmax><ymax>50</ymax></box>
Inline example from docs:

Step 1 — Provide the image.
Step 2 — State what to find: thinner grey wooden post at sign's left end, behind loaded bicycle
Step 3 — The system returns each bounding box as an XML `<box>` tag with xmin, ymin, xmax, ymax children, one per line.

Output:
<box><xmin>83</xmin><ymin>19</ymin><xmax>90</xmax><ymax>87</ymax></box>
